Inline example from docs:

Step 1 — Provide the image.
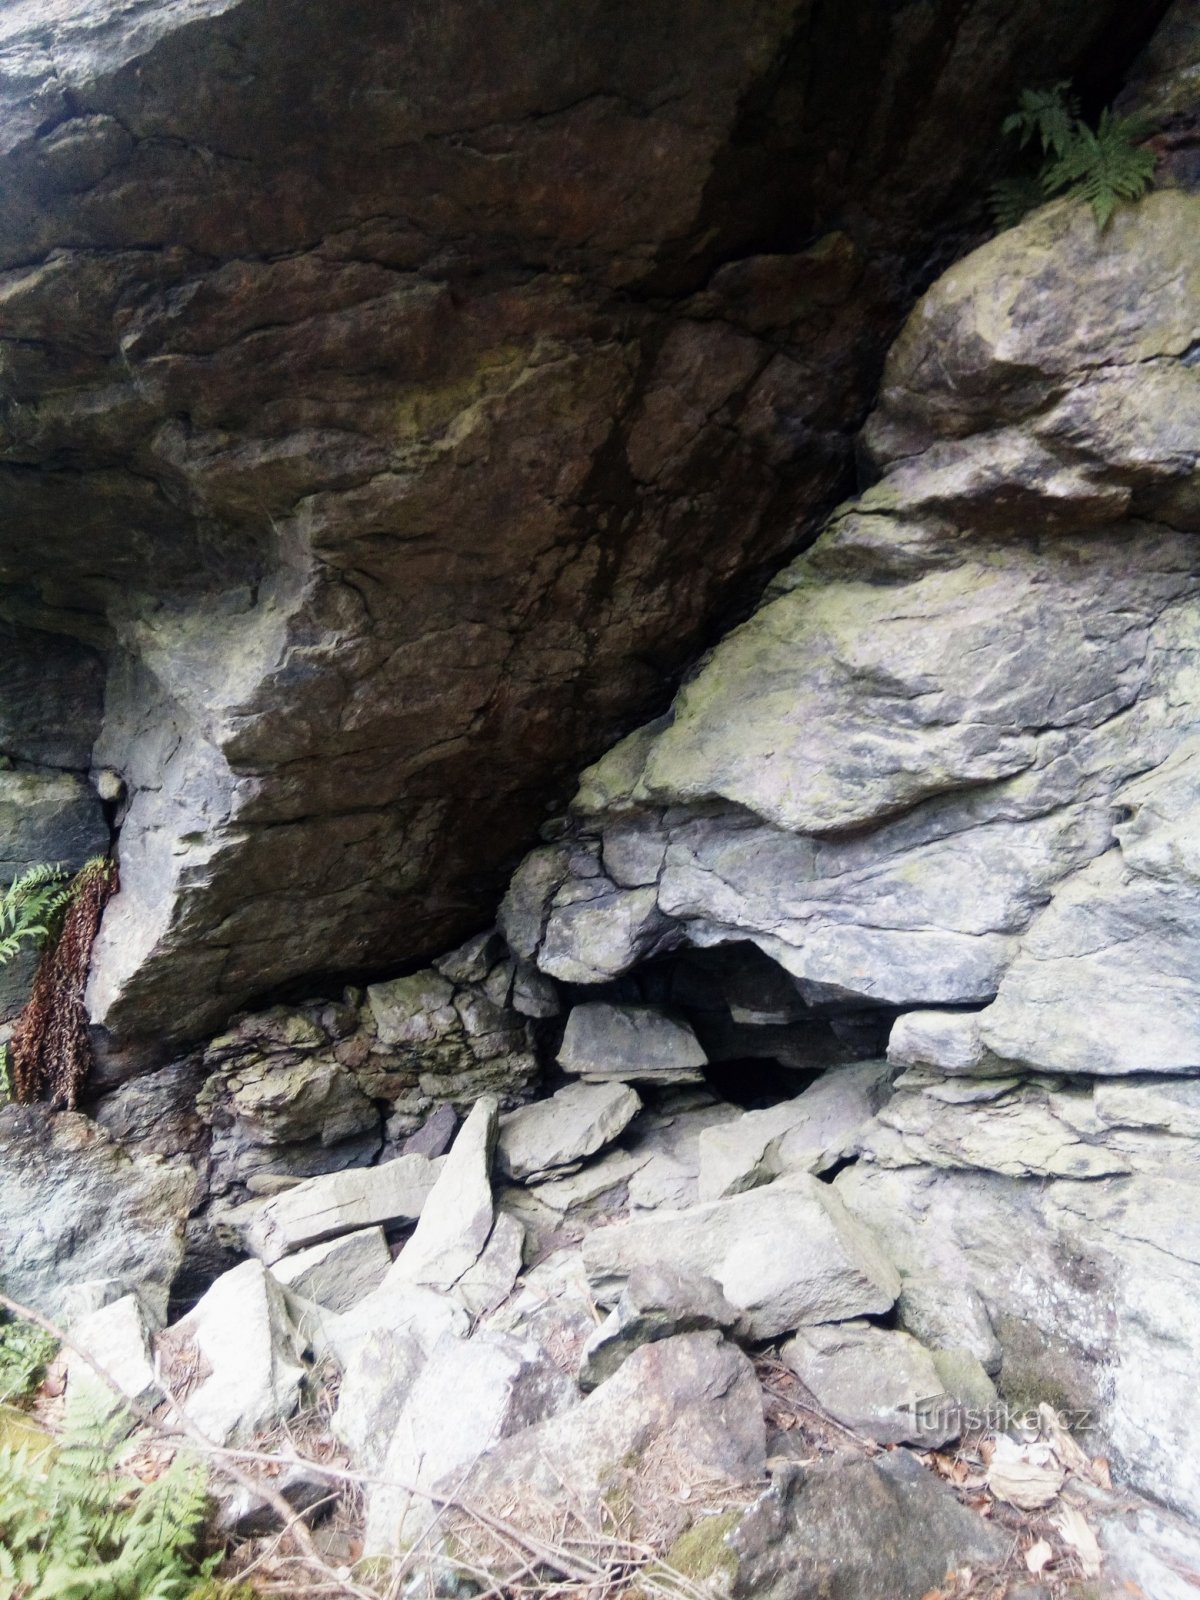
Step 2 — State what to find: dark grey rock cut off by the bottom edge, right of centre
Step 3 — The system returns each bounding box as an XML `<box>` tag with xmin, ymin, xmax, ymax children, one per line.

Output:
<box><xmin>726</xmin><ymin>1450</ymin><xmax>1010</xmax><ymax>1600</ymax></box>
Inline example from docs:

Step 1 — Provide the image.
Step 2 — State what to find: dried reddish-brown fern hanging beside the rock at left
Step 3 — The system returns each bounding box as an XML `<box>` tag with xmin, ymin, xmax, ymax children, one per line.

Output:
<box><xmin>10</xmin><ymin>861</ymin><xmax>117</xmax><ymax>1110</ymax></box>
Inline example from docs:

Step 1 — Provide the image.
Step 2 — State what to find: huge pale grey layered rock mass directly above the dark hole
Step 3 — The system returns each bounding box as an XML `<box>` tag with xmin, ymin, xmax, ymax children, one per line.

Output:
<box><xmin>521</xmin><ymin>189</ymin><xmax>1200</xmax><ymax>1075</ymax></box>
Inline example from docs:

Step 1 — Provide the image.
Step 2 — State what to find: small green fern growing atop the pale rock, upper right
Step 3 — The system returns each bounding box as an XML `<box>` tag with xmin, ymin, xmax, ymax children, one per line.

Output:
<box><xmin>992</xmin><ymin>83</ymin><xmax>1157</xmax><ymax>229</ymax></box>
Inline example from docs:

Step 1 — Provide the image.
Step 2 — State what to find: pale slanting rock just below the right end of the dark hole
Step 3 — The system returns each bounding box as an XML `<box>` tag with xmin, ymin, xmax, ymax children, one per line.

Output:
<box><xmin>699</xmin><ymin>1061</ymin><xmax>891</xmax><ymax>1200</ymax></box>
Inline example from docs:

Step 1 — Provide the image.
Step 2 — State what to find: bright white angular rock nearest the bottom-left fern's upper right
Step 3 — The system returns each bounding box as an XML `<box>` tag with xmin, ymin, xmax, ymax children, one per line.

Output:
<box><xmin>157</xmin><ymin>1261</ymin><xmax>304</xmax><ymax>1445</ymax></box>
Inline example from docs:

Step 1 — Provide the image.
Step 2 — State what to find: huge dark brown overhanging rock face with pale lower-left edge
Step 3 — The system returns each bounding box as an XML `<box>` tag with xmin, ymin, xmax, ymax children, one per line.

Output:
<box><xmin>0</xmin><ymin>0</ymin><xmax>1162</xmax><ymax>1042</ymax></box>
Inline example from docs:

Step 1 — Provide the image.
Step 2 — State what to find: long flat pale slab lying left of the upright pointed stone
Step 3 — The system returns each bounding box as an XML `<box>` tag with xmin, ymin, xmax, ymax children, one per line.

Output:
<box><xmin>242</xmin><ymin>1155</ymin><xmax>443</xmax><ymax>1264</ymax></box>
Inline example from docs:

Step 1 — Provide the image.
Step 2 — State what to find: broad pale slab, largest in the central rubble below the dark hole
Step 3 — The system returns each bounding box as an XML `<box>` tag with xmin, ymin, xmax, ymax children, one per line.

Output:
<box><xmin>584</xmin><ymin>1174</ymin><xmax>901</xmax><ymax>1339</ymax></box>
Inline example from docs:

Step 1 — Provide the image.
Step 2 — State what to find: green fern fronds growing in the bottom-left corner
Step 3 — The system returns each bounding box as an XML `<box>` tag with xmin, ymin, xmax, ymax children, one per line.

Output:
<box><xmin>0</xmin><ymin>1387</ymin><xmax>250</xmax><ymax>1600</ymax></box>
